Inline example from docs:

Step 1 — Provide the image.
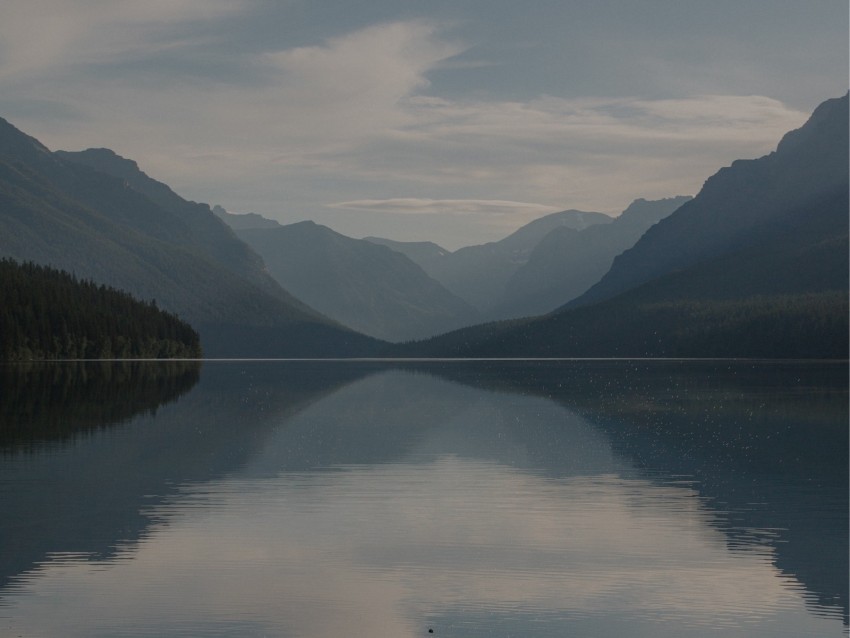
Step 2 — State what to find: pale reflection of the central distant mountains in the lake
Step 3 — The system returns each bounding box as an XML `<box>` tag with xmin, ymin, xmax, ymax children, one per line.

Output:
<box><xmin>245</xmin><ymin>367</ymin><xmax>629</xmax><ymax>477</ymax></box>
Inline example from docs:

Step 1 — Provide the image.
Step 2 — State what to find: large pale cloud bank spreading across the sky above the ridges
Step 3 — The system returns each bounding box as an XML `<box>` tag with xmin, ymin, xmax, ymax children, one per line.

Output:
<box><xmin>0</xmin><ymin>12</ymin><xmax>806</xmax><ymax>248</ymax></box>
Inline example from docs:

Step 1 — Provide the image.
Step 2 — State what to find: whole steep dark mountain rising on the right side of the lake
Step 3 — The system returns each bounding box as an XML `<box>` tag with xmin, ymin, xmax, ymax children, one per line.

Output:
<box><xmin>405</xmin><ymin>95</ymin><xmax>850</xmax><ymax>359</ymax></box>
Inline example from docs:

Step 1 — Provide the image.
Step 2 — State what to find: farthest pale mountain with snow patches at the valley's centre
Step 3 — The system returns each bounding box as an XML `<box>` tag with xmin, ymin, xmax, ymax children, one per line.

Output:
<box><xmin>370</xmin><ymin>210</ymin><xmax>611</xmax><ymax>316</ymax></box>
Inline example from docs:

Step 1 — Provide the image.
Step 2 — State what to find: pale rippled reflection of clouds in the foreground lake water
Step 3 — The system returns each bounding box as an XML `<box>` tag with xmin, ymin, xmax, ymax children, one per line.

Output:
<box><xmin>2</xmin><ymin>457</ymin><xmax>834</xmax><ymax>637</ymax></box>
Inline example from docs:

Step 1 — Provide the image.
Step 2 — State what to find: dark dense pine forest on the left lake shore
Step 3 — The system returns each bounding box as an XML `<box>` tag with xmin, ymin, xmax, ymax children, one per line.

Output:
<box><xmin>0</xmin><ymin>259</ymin><xmax>201</xmax><ymax>361</ymax></box>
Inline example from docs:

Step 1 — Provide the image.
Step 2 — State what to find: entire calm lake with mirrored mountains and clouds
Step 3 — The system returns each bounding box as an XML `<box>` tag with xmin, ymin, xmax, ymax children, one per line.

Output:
<box><xmin>0</xmin><ymin>361</ymin><xmax>848</xmax><ymax>638</ymax></box>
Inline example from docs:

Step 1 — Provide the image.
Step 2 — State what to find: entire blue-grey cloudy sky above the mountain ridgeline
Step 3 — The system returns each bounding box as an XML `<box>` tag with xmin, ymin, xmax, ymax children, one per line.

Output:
<box><xmin>0</xmin><ymin>0</ymin><xmax>850</xmax><ymax>250</ymax></box>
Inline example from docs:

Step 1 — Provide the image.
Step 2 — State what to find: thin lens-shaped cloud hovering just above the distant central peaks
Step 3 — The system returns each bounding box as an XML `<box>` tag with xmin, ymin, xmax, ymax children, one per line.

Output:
<box><xmin>328</xmin><ymin>197</ymin><xmax>560</xmax><ymax>216</ymax></box>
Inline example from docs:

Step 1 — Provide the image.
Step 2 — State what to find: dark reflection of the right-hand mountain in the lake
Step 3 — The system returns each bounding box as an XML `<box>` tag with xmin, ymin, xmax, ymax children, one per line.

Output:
<box><xmin>418</xmin><ymin>362</ymin><xmax>850</xmax><ymax>624</ymax></box>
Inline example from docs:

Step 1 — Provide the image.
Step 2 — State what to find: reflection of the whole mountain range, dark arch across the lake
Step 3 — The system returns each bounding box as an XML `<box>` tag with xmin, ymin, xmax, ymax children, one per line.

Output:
<box><xmin>0</xmin><ymin>362</ymin><xmax>848</xmax><ymax>628</ymax></box>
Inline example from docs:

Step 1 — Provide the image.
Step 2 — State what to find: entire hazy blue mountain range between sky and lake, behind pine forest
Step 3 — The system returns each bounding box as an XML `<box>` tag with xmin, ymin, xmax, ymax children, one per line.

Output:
<box><xmin>0</xmin><ymin>95</ymin><xmax>850</xmax><ymax>357</ymax></box>
